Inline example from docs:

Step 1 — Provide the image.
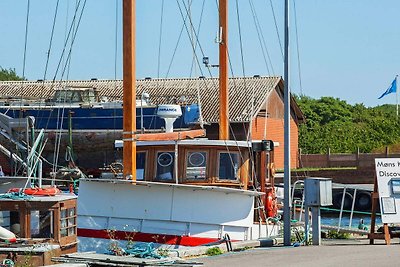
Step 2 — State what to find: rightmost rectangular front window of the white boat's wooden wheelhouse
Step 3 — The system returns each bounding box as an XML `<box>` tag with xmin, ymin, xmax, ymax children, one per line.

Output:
<box><xmin>218</xmin><ymin>152</ymin><xmax>240</xmax><ymax>180</ymax></box>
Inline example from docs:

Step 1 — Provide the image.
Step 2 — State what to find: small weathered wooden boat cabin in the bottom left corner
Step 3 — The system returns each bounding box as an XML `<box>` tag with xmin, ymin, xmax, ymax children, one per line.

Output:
<box><xmin>0</xmin><ymin>194</ymin><xmax>78</xmax><ymax>266</ymax></box>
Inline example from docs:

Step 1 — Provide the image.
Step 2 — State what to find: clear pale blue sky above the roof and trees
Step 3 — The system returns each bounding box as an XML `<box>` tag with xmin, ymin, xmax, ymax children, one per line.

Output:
<box><xmin>0</xmin><ymin>0</ymin><xmax>400</xmax><ymax>106</ymax></box>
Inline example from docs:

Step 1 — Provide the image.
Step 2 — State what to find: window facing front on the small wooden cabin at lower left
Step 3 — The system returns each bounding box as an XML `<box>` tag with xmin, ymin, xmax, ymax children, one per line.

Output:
<box><xmin>31</xmin><ymin>210</ymin><xmax>53</xmax><ymax>238</ymax></box>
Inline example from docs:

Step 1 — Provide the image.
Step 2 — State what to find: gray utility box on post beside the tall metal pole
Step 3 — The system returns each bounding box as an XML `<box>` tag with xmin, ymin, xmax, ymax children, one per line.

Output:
<box><xmin>304</xmin><ymin>177</ymin><xmax>332</xmax><ymax>207</ymax></box>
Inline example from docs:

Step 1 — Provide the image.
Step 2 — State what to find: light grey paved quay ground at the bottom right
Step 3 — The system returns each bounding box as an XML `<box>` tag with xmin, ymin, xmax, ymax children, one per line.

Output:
<box><xmin>194</xmin><ymin>238</ymin><xmax>400</xmax><ymax>267</ymax></box>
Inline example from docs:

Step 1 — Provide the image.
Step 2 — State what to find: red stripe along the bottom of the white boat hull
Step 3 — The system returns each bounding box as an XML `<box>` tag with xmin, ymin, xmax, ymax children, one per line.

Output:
<box><xmin>78</xmin><ymin>228</ymin><xmax>219</xmax><ymax>246</ymax></box>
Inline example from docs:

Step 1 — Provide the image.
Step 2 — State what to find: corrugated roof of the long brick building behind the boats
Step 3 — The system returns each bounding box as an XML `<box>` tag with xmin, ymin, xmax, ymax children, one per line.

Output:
<box><xmin>0</xmin><ymin>77</ymin><xmax>282</xmax><ymax>123</ymax></box>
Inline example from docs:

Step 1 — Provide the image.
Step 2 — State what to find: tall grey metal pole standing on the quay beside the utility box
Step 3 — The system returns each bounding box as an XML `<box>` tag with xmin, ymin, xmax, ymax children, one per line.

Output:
<box><xmin>283</xmin><ymin>0</ymin><xmax>292</xmax><ymax>246</ymax></box>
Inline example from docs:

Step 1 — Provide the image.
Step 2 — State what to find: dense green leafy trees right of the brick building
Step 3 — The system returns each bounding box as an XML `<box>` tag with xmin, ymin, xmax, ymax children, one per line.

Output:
<box><xmin>296</xmin><ymin>96</ymin><xmax>400</xmax><ymax>154</ymax></box>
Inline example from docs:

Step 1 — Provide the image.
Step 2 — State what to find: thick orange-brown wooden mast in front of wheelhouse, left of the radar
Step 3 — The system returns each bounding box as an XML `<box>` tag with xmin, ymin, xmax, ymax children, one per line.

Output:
<box><xmin>122</xmin><ymin>0</ymin><xmax>136</xmax><ymax>181</ymax></box>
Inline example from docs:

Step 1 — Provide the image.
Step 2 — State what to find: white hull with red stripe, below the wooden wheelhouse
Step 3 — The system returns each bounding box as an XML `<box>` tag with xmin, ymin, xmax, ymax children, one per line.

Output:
<box><xmin>78</xmin><ymin>179</ymin><xmax>278</xmax><ymax>252</ymax></box>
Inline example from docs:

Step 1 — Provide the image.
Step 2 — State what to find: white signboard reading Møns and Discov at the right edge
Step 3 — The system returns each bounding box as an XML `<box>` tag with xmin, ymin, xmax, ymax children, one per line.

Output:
<box><xmin>375</xmin><ymin>158</ymin><xmax>400</xmax><ymax>223</ymax></box>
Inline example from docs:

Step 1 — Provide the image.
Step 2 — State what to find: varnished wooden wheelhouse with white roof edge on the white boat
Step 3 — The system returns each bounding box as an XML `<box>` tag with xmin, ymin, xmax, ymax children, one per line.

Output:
<box><xmin>111</xmin><ymin>139</ymin><xmax>273</xmax><ymax>192</ymax></box>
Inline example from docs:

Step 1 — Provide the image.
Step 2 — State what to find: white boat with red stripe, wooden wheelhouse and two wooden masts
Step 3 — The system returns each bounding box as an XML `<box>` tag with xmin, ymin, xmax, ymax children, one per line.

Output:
<box><xmin>78</xmin><ymin>0</ymin><xmax>278</xmax><ymax>252</ymax></box>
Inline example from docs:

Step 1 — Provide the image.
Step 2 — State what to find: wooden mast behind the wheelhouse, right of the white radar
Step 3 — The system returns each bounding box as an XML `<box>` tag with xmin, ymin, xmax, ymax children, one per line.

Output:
<box><xmin>219</xmin><ymin>0</ymin><xmax>229</xmax><ymax>140</ymax></box>
